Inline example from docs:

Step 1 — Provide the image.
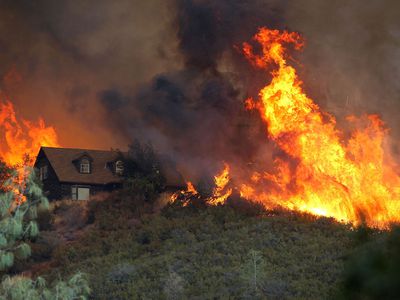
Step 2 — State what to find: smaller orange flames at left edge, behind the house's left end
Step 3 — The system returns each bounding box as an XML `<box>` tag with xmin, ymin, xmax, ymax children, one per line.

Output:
<box><xmin>0</xmin><ymin>100</ymin><xmax>59</xmax><ymax>166</ymax></box>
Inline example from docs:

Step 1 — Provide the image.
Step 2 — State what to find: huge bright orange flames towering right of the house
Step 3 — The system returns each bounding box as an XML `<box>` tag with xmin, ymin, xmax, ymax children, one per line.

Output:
<box><xmin>240</xmin><ymin>28</ymin><xmax>400</xmax><ymax>228</ymax></box>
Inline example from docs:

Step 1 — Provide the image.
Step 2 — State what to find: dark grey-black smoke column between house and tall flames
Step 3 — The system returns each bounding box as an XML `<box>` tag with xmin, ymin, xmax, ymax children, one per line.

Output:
<box><xmin>99</xmin><ymin>0</ymin><xmax>282</xmax><ymax>177</ymax></box>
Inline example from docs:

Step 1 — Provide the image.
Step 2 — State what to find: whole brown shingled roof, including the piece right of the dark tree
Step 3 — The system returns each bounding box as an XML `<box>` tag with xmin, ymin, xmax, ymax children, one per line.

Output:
<box><xmin>34</xmin><ymin>147</ymin><xmax>185</xmax><ymax>187</ymax></box>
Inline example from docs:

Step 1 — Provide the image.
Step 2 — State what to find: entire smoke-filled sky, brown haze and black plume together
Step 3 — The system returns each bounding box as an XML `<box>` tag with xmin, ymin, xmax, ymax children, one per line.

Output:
<box><xmin>0</xmin><ymin>0</ymin><xmax>400</xmax><ymax>178</ymax></box>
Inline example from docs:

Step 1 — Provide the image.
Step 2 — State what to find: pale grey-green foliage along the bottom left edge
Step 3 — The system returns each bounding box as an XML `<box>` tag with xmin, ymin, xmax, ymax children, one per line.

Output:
<box><xmin>0</xmin><ymin>273</ymin><xmax>90</xmax><ymax>300</ymax></box>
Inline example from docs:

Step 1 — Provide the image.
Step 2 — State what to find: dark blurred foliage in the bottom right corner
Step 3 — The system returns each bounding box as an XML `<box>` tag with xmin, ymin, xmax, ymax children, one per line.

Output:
<box><xmin>341</xmin><ymin>227</ymin><xmax>400</xmax><ymax>299</ymax></box>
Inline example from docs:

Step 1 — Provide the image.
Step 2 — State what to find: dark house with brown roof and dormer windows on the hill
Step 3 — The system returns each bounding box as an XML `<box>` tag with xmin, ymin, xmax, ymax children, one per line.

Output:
<box><xmin>34</xmin><ymin>147</ymin><xmax>184</xmax><ymax>200</ymax></box>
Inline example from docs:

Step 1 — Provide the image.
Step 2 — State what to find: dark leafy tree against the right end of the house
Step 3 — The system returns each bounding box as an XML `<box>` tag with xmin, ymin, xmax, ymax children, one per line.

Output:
<box><xmin>123</xmin><ymin>140</ymin><xmax>166</xmax><ymax>201</ymax></box>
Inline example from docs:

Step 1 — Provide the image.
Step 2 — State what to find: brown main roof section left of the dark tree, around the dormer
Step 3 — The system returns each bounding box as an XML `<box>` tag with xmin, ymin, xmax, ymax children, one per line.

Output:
<box><xmin>39</xmin><ymin>147</ymin><xmax>122</xmax><ymax>184</ymax></box>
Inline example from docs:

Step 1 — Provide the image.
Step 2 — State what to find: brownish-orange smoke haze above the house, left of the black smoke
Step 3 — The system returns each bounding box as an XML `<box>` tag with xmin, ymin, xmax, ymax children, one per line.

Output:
<box><xmin>0</xmin><ymin>0</ymin><xmax>180</xmax><ymax>148</ymax></box>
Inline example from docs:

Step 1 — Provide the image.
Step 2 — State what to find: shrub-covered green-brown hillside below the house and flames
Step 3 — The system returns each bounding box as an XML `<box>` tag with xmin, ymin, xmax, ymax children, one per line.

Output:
<box><xmin>33</xmin><ymin>193</ymin><xmax>352</xmax><ymax>299</ymax></box>
